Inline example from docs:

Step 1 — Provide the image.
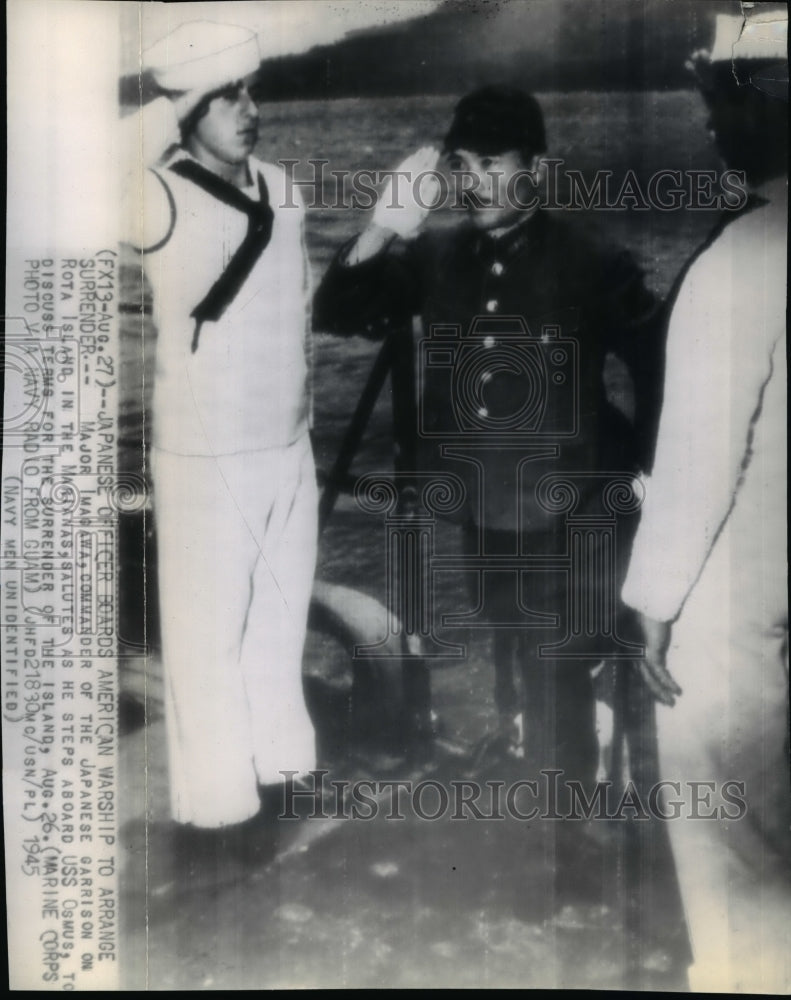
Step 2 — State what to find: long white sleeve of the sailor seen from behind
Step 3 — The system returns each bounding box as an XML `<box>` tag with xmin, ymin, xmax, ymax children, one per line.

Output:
<box><xmin>622</xmin><ymin>236</ymin><xmax>770</xmax><ymax>621</ymax></box>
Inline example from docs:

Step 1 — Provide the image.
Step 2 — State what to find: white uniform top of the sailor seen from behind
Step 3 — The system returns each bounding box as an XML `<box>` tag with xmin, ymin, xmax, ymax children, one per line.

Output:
<box><xmin>623</xmin><ymin>179</ymin><xmax>788</xmax><ymax>621</ymax></box>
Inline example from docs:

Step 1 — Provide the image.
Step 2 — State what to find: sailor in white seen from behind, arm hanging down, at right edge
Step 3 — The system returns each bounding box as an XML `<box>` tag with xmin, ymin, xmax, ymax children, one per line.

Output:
<box><xmin>622</xmin><ymin>4</ymin><xmax>791</xmax><ymax>993</ymax></box>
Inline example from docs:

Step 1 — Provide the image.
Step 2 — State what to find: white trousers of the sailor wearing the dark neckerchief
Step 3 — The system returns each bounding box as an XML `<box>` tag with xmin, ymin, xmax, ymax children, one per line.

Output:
<box><xmin>152</xmin><ymin>434</ymin><xmax>317</xmax><ymax>827</ymax></box>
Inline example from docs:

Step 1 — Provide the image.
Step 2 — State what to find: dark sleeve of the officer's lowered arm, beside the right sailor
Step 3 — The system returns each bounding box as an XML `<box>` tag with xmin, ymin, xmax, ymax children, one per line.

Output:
<box><xmin>596</xmin><ymin>250</ymin><xmax>666</xmax><ymax>471</ymax></box>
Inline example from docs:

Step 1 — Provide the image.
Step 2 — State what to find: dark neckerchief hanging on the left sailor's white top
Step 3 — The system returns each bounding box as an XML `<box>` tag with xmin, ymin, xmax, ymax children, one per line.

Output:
<box><xmin>169</xmin><ymin>160</ymin><xmax>274</xmax><ymax>354</ymax></box>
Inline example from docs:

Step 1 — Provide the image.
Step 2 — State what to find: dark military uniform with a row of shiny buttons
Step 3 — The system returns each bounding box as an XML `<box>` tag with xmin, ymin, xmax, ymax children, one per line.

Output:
<box><xmin>314</xmin><ymin>211</ymin><xmax>661</xmax><ymax>781</ymax></box>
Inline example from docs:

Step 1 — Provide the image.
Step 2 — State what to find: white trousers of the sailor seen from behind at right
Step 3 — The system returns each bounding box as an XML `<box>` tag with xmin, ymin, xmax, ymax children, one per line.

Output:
<box><xmin>658</xmin><ymin>525</ymin><xmax>791</xmax><ymax>994</ymax></box>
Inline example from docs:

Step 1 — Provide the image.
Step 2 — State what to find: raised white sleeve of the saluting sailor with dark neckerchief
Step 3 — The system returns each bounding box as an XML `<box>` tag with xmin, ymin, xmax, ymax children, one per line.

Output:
<box><xmin>119</xmin><ymin>97</ymin><xmax>180</xmax><ymax>250</ymax></box>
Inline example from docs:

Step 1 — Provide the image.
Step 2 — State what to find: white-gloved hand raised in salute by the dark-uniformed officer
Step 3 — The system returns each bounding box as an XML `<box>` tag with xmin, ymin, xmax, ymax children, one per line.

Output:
<box><xmin>372</xmin><ymin>146</ymin><xmax>440</xmax><ymax>237</ymax></box>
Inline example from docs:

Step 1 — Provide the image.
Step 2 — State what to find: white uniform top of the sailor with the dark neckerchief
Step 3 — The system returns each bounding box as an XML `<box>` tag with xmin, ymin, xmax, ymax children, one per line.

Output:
<box><xmin>122</xmin><ymin>99</ymin><xmax>310</xmax><ymax>456</ymax></box>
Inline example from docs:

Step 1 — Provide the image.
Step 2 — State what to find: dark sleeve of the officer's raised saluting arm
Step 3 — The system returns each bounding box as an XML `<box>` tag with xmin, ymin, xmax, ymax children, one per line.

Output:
<box><xmin>313</xmin><ymin>232</ymin><xmax>423</xmax><ymax>339</ymax></box>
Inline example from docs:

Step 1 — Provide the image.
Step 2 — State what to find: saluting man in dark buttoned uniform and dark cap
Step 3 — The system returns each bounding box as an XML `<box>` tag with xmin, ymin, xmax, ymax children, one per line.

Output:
<box><xmin>314</xmin><ymin>86</ymin><xmax>656</xmax><ymax>804</ymax></box>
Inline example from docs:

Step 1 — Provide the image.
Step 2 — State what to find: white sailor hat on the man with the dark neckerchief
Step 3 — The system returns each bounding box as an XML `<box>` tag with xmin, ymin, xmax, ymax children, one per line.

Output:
<box><xmin>143</xmin><ymin>21</ymin><xmax>261</xmax><ymax>93</ymax></box>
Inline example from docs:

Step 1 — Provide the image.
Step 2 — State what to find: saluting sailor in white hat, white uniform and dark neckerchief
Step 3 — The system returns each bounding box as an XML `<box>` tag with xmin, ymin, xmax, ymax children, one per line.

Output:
<box><xmin>127</xmin><ymin>22</ymin><xmax>317</xmax><ymax>852</ymax></box>
